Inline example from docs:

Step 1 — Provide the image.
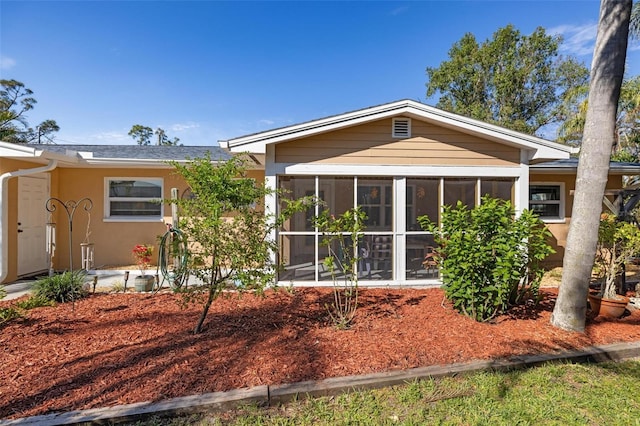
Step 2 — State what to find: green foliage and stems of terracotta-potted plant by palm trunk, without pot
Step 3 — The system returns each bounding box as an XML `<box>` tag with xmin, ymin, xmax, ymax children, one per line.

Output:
<box><xmin>594</xmin><ymin>213</ymin><xmax>640</xmax><ymax>299</ymax></box>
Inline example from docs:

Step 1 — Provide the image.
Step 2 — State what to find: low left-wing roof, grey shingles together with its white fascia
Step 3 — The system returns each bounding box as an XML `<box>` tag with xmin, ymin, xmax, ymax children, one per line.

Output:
<box><xmin>0</xmin><ymin>142</ymin><xmax>231</xmax><ymax>168</ymax></box>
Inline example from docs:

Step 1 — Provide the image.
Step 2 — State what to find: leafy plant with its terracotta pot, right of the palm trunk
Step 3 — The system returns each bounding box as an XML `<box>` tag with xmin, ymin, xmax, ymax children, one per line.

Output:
<box><xmin>589</xmin><ymin>213</ymin><xmax>640</xmax><ymax>318</ymax></box>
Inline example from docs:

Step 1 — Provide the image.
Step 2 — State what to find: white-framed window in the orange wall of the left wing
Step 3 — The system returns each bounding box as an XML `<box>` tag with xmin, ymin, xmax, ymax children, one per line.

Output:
<box><xmin>104</xmin><ymin>177</ymin><xmax>164</xmax><ymax>222</ymax></box>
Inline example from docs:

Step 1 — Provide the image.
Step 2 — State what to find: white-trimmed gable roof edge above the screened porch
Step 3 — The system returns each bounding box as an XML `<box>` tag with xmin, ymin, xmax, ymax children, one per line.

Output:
<box><xmin>221</xmin><ymin>99</ymin><xmax>575</xmax><ymax>160</ymax></box>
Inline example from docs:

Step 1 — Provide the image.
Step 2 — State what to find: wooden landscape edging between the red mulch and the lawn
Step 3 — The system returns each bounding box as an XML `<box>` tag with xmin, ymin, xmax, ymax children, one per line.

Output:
<box><xmin>5</xmin><ymin>342</ymin><xmax>640</xmax><ymax>426</ymax></box>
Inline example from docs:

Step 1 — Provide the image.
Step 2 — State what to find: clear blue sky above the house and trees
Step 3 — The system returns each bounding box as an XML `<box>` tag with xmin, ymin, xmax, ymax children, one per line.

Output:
<box><xmin>0</xmin><ymin>0</ymin><xmax>640</xmax><ymax>145</ymax></box>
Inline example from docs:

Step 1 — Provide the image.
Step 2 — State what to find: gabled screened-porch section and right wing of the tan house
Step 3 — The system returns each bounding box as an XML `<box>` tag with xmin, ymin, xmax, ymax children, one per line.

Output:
<box><xmin>222</xmin><ymin>100</ymin><xmax>640</xmax><ymax>285</ymax></box>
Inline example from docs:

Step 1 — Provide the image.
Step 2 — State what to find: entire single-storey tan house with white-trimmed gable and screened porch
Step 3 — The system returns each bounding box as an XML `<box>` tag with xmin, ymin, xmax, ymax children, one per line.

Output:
<box><xmin>0</xmin><ymin>100</ymin><xmax>640</xmax><ymax>286</ymax></box>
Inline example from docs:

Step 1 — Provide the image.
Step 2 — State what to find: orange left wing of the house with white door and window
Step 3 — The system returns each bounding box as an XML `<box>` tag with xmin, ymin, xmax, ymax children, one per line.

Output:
<box><xmin>0</xmin><ymin>142</ymin><xmax>235</xmax><ymax>283</ymax></box>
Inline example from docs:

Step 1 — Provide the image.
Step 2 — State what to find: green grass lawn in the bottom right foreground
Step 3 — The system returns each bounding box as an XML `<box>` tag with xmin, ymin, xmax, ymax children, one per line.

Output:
<box><xmin>138</xmin><ymin>360</ymin><xmax>640</xmax><ymax>426</ymax></box>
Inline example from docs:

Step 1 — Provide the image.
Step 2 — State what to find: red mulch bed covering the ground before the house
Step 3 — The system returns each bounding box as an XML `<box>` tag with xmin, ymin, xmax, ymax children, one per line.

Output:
<box><xmin>0</xmin><ymin>288</ymin><xmax>640</xmax><ymax>418</ymax></box>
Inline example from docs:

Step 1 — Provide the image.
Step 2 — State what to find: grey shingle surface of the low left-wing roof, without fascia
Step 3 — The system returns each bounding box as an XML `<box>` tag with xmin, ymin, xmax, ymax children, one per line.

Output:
<box><xmin>28</xmin><ymin>144</ymin><xmax>231</xmax><ymax>161</ymax></box>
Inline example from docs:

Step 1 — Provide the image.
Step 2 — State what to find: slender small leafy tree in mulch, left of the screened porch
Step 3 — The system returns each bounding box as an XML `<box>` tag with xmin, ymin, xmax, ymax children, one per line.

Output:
<box><xmin>172</xmin><ymin>155</ymin><xmax>313</xmax><ymax>333</ymax></box>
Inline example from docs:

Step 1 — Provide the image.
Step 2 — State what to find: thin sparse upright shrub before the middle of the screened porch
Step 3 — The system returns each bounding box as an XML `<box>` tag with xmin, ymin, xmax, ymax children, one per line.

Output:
<box><xmin>313</xmin><ymin>207</ymin><xmax>367</xmax><ymax>329</ymax></box>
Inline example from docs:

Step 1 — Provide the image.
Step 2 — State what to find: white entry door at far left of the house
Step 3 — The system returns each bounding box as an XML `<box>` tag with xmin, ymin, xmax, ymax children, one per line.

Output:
<box><xmin>18</xmin><ymin>175</ymin><xmax>49</xmax><ymax>276</ymax></box>
